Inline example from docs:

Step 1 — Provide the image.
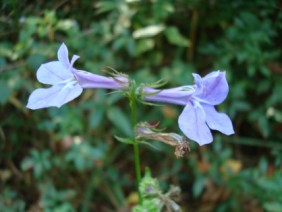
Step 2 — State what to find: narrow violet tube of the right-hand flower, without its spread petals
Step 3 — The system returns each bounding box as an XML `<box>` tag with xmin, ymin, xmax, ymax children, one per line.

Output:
<box><xmin>142</xmin><ymin>87</ymin><xmax>194</xmax><ymax>105</ymax></box>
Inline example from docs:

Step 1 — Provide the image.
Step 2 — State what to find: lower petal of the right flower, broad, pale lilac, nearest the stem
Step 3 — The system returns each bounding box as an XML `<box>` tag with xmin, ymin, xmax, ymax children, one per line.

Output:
<box><xmin>178</xmin><ymin>102</ymin><xmax>213</xmax><ymax>146</ymax></box>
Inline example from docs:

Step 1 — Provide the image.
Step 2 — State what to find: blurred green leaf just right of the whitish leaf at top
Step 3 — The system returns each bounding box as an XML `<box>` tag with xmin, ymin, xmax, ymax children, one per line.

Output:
<box><xmin>165</xmin><ymin>27</ymin><xmax>190</xmax><ymax>47</ymax></box>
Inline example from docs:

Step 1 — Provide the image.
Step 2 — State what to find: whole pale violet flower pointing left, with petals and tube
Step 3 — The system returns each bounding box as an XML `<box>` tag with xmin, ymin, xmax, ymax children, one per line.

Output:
<box><xmin>27</xmin><ymin>43</ymin><xmax>128</xmax><ymax>110</ymax></box>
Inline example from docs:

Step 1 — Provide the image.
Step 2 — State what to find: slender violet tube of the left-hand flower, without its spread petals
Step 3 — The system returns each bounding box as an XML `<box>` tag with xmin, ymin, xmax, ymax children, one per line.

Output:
<box><xmin>73</xmin><ymin>70</ymin><xmax>126</xmax><ymax>89</ymax></box>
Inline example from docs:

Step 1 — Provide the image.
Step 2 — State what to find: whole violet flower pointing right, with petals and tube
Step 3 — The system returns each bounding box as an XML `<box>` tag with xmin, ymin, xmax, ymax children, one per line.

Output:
<box><xmin>143</xmin><ymin>71</ymin><xmax>234</xmax><ymax>145</ymax></box>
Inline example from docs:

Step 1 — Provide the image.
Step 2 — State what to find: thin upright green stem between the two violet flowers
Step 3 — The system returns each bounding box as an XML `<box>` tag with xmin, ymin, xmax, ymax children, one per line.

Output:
<box><xmin>129</xmin><ymin>82</ymin><xmax>142</xmax><ymax>205</ymax></box>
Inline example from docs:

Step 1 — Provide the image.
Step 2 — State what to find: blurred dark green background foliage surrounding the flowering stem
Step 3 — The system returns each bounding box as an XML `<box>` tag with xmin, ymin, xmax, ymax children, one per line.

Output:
<box><xmin>0</xmin><ymin>0</ymin><xmax>282</xmax><ymax>211</ymax></box>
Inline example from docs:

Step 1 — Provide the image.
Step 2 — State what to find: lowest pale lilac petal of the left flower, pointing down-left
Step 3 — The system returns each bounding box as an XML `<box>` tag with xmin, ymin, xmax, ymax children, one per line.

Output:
<box><xmin>26</xmin><ymin>83</ymin><xmax>82</xmax><ymax>110</ymax></box>
